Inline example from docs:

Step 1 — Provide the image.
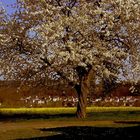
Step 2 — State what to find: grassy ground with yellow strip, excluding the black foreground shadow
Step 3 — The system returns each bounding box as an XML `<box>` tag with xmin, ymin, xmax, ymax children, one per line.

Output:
<box><xmin>0</xmin><ymin>107</ymin><xmax>140</xmax><ymax>139</ymax></box>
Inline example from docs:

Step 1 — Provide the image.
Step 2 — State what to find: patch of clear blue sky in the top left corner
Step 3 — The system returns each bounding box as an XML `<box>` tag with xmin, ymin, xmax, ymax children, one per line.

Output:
<box><xmin>0</xmin><ymin>0</ymin><xmax>16</xmax><ymax>14</ymax></box>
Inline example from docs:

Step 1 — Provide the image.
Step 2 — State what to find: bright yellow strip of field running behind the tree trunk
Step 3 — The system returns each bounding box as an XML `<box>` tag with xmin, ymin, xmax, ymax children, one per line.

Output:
<box><xmin>0</xmin><ymin>107</ymin><xmax>140</xmax><ymax>115</ymax></box>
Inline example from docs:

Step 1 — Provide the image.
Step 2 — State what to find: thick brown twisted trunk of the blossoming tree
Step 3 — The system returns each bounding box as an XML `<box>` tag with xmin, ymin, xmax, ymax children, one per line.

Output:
<box><xmin>75</xmin><ymin>70</ymin><xmax>92</xmax><ymax>119</ymax></box>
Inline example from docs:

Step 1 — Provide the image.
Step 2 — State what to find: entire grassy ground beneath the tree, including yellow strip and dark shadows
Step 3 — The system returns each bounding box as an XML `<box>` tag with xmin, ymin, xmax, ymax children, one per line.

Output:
<box><xmin>0</xmin><ymin>107</ymin><xmax>140</xmax><ymax>140</ymax></box>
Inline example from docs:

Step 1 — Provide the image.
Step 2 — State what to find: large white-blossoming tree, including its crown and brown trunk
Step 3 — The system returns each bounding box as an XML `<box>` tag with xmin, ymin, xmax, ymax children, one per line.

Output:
<box><xmin>0</xmin><ymin>0</ymin><xmax>140</xmax><ymax>118</ymax></box>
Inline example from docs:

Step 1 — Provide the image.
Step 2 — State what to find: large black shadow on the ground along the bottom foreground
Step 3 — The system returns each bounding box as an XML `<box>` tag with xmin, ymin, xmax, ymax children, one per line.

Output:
<box><xmin>20</xmin><ymin>126</ymin><xmax>140</xmax><ymax>140</ymax></box>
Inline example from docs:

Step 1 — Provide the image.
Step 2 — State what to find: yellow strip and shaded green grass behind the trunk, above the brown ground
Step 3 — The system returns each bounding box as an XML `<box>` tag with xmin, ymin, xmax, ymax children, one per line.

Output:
<box><xmin>0</xmin><ymin>107</ymin><xmax>140</xmax><ymax>120</ymax></box>
